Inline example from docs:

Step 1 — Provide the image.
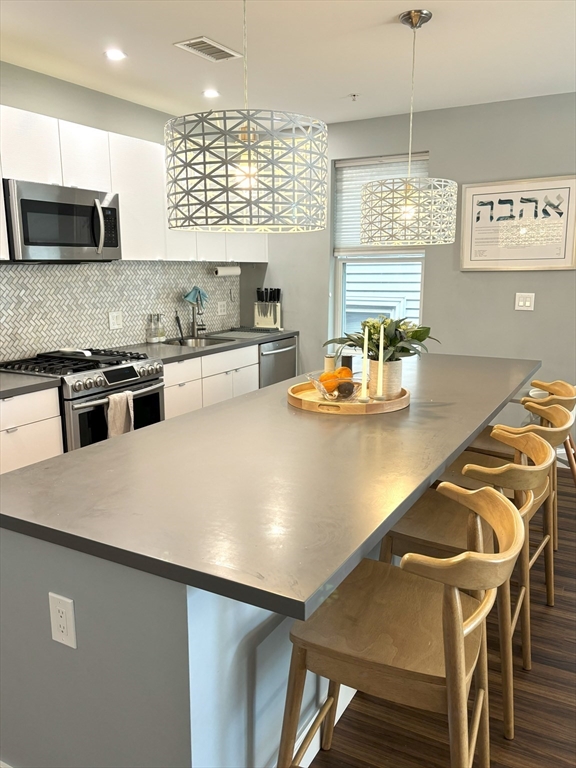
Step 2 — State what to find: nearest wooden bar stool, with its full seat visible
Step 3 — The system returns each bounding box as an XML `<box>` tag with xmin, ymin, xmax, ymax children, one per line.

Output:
<box><xmin>278</xmin><ymin>483</ymin><xmax>524</xmax><ymax>768</ymax></box>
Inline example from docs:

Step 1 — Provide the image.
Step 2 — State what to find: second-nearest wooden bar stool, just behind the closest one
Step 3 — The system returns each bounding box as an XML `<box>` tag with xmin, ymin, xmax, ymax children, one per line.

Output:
<box><xmin>380</xmin><ymin>427</ymin><xmax>555</xmax><ymax>739</ymax></box>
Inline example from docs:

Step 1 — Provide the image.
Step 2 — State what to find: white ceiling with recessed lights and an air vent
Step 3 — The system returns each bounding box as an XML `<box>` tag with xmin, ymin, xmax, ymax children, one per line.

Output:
<box><xmin>0</xmin><ymin>0</ymin><xmax>576</xmax><ymax>123</ymax></box>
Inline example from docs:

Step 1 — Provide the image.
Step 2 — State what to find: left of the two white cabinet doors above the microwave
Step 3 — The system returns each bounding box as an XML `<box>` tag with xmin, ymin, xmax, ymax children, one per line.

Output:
<box><xmin>0</xmin><ymin>106</ymin><xmax>62</xmax><ymax>184</ymax></box>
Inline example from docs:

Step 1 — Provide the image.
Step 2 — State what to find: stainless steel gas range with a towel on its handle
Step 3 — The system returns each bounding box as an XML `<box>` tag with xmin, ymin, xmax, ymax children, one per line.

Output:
<box><xmin>0</xmin><ymin>349</ymin><xmax>164</xmax><ymax>451</ymax></box>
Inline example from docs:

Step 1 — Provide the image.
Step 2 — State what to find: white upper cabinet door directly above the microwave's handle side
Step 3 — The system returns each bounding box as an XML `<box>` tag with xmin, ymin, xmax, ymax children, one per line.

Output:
<box><xmin>59</xmin><ymin>120</ymin><xmax>112</xmax><ymax>192</ymax></box>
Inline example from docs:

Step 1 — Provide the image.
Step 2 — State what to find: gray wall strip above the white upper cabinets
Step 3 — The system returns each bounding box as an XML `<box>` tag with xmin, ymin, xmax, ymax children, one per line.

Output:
<box><xmin>0</xmin><ymin>62</ymin><xmax>174</xmax><ymax>142</ymax></box>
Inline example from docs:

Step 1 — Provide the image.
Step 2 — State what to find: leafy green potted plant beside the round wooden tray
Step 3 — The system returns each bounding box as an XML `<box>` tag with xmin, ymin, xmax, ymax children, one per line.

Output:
<box><xmin>324</xmin><ymin>315</ymin><xmax>438</xmax><ymax>400</ymax></box>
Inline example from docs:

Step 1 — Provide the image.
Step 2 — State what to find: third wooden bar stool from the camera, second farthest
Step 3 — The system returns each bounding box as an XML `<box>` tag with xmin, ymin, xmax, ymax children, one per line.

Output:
<box><xmin>468</xmin><ymin>402</ymin><xmax>575</xmax><ymax>549</ymax></box>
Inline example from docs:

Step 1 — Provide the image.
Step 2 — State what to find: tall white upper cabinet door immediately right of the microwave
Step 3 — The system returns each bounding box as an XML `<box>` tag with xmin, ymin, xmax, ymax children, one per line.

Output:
<box><xmin>109</xmin><ymin>133</ymin><xmax>167</xmax><ymax>261</ymax></box>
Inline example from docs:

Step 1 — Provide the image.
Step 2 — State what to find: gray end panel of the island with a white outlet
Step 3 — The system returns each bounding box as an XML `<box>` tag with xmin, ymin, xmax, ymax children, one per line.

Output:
<box><xmin>0</xmin><ymin>531</ymin><xmax>191</xmax><ymax>768</ymax></box>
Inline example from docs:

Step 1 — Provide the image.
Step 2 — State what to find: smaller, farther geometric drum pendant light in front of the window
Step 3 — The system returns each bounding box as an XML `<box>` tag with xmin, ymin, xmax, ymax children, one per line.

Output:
<box><xmin>360</xmin><ymin>10</ymin><xmax>458</xmax><ymax>246</ymax></box>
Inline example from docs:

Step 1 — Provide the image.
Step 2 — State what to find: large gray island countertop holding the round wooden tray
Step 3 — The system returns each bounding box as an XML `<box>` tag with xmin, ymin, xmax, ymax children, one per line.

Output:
<box><xmin>0</xmin><ymin>354</ymin><xmax>540</xmax><ymax>618</ymax></box>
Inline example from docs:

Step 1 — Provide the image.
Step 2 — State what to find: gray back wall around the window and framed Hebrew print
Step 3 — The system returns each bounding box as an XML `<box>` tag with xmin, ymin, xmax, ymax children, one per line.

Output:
<box><xmin>266</xmin><ymin>94</ymin><xmax>576</xmax><ymax>381</ymax></box>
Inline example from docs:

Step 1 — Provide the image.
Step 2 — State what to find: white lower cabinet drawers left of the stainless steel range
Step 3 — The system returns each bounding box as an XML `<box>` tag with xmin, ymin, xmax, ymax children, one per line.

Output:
<box><xmin>0</xmin><ymin>389</ymin><xmax>63</xmax><ymax>474</ymax></box>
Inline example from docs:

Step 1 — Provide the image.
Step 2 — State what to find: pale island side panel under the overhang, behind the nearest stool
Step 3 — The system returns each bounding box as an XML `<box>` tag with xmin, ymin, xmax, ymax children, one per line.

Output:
<box><xmin>188</xmin><ymin>587</ymin><xmax>355</xmax><ymax>768</ymax></box>
